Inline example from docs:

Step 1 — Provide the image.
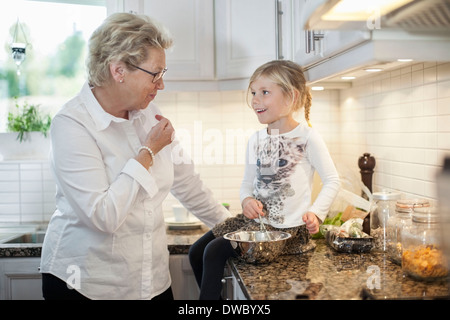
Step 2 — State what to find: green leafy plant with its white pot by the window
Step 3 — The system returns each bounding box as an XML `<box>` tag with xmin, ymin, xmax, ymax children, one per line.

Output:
<box><xmin>0</xmin><ymin>101</ymin><xmax>51</xmax><ymax>160</ymax></box>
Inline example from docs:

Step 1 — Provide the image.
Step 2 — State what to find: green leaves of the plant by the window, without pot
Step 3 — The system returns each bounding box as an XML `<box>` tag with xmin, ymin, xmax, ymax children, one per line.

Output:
<box><xmin>8</xmin><ymin>101</ymin><xmax>52</xmax><ymax>142</ymax></box>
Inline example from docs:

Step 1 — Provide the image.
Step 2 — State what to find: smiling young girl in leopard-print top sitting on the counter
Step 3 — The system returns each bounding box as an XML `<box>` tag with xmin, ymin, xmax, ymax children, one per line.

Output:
<box><xmin>189</xmin><ymin>60</ymin><xmax>340</xmax><ymax>300</ymax></box>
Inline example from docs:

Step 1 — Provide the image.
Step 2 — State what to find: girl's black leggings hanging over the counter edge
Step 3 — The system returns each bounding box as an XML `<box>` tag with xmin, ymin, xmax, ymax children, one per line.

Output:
<box><xmin>189</xmin><ymin>231</ymin><xmax>236</xmax><ymax>300</ymax></box>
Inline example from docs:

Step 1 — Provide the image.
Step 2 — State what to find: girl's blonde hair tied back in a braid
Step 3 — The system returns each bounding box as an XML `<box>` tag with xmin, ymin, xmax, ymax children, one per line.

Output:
<box><xmin>247</xmin><ymin>60</ymin><xmax>312</xmax><ymax>127</ymax></box>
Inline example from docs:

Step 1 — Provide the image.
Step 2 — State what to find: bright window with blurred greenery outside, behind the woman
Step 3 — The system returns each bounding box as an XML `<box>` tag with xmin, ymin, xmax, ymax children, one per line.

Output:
<box><xmin>0</xmin><ymin>0</ymin><xmax>107</xmax><ymax>132</ymax></box>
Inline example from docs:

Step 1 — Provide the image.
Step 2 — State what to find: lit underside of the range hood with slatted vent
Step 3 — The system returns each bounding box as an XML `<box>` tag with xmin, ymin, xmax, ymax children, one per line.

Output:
<box><xmin>305</xmin><ymin>0</ymin><xmax>450</xmax><ymax>35</ymax></box>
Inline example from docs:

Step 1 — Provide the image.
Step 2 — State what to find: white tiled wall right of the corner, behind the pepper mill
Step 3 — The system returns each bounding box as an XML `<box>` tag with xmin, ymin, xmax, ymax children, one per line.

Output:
<box><xmin>339</xmin><ymin>63</ymin><xmax>450</xmax><ymax>199</ymax></box>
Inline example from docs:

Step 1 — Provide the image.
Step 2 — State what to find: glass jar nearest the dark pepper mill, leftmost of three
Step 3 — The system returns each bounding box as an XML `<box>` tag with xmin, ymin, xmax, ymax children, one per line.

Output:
<box><xmin>370</xmin><ymin>191</ymin><xmax>401</xmax><ymax>252</ymax></box>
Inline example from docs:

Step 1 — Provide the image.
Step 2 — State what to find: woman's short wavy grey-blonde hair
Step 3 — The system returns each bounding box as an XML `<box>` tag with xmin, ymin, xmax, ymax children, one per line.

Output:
<box><xmin>86</xmin><ymin>13</ymin><xmax>172</xmax><ymax>86</ymax></box>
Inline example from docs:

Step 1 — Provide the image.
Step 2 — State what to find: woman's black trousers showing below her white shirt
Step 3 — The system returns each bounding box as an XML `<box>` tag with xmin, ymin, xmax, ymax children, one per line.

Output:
<box><xmin>42</xmin><ymin>273</ymin><xmax>173</xmax><ymax>300</ymax></box>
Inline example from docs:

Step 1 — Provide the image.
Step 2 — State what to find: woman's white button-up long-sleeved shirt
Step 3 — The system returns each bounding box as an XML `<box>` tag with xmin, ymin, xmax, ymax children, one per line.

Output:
<box><xmin>41</xmin><ymin>83</ymin><xmax>230</xmax><ymax>299</ymax></box>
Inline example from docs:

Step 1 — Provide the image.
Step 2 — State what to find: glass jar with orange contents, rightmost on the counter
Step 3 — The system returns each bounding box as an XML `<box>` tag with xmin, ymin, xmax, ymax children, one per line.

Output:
<box><xmin>402</xmin><ymin>207</ymin><xmax>448</xmax><ymax>281</ymax></box>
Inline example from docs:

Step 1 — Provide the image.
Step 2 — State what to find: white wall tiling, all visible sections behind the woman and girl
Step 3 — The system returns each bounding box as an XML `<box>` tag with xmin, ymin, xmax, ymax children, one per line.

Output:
<box><xmin>0</xmin><ymin>63</ymin><xmax>450</xmax><ymax>222</ymax></box>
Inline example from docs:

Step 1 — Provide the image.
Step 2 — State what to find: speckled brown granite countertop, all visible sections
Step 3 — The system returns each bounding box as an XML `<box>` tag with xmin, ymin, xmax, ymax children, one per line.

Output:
<box><xmin>0</xmin><ymin>225</ymin><xmax>450</xmax><ymax>300</ymax></box>
